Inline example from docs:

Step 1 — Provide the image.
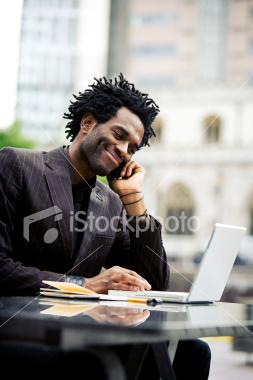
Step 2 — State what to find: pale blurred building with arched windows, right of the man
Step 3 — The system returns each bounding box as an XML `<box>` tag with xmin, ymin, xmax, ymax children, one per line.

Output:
<box><xmin>108</xmin><ymin>0</ymin><xmax>253</xmax><ymax>258</ymax></box>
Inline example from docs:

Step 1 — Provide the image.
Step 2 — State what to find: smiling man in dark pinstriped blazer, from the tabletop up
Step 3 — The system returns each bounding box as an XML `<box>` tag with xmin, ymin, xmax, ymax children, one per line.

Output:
<box><xmin>0</xmin><ymin>75</ymin><xmax>211</xmax><ymax>378</ymax></box>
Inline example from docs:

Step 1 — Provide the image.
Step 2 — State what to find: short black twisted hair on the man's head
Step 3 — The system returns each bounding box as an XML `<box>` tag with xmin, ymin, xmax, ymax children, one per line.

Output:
<box><xmin>63</xmin><ymin>73</ymin><xmax>160</xmax><ymax>148</ymax></box>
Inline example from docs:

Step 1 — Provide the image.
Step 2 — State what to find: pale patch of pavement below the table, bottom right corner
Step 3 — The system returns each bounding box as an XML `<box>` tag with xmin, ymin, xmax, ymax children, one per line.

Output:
<box><xmin>203</xmin><ymin>337</ymin><xmax>253</xmax><ymax>380</ymax></box>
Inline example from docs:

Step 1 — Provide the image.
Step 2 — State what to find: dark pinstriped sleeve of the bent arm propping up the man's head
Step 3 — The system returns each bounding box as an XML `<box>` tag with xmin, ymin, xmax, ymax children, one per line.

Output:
<box><xmin>104</xmin><ymin>213</ymin><xmax>170</xmax><ymax>290</ymax></box>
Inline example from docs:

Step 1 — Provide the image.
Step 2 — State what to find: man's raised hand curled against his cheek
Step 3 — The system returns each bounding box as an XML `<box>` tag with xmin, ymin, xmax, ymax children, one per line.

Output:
<box><xmin>107</xmin><ymin>161</ymin><xmax>146</xmax><ymax>195</ymax></box>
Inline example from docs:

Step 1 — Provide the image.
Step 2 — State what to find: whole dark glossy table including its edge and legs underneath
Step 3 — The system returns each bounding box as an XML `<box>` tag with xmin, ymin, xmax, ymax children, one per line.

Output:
<box><xmin>0</xmin><ymin>296</ymin><xmax>253</xmax><ymax>380</ymax></box>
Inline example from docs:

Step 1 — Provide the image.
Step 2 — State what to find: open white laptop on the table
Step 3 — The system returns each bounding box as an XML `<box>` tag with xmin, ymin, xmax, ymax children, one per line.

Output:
<box><xmin>109</xmin><ymin>223</ymin><xmax>246</xmax><ymax>304</ymax></box>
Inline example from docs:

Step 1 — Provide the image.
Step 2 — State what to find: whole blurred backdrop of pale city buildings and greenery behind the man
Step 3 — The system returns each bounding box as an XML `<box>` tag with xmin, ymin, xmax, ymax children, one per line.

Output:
<box><xmin>0</xmin><ymin>0</ymin><xmax>253</xmax><ymax>374</ymax></box>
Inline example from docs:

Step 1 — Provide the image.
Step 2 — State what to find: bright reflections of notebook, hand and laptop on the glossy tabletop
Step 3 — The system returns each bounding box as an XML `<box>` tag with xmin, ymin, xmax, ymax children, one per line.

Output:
<box><xmin>40</xmin><ymin>299</ymin><xmax>252</xmax><ymax>328</ymax></box>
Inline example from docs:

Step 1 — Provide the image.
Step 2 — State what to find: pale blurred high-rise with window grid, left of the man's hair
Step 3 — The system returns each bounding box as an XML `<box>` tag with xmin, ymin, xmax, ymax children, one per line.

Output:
<box><xmin>16</xmin><ymin>0</ymin><xmax>109</xmax><ymax>146</ymax></box>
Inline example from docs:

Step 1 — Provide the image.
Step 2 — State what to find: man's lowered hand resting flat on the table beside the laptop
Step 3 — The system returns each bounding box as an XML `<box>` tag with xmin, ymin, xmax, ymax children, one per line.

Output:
<box><xmin>83</xmin><ymin>266</ymin><xmax>151</xmax><ymax>294</ymax></box>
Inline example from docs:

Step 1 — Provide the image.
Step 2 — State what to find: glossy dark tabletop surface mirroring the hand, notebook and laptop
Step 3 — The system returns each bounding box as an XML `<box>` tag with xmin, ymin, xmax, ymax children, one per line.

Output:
<box><xmin>0</xmin><ymin>297</ymin><xmax>253</xmax><ymax>334</ymax></box>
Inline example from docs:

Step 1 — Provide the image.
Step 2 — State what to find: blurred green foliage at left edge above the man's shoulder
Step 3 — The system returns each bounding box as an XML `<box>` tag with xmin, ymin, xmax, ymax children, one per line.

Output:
<box><xmin>0</xmin><ymin>120</ymin><xmax>35</xmax><ymax>149</ymax></box>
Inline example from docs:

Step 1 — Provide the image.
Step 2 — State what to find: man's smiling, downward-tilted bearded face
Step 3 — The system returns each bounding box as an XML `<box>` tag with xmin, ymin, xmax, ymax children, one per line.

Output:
<box><xmin>81</xmin><ymin>107</ymin><xmax>144</xmax><ymax>176</ymax></box>
